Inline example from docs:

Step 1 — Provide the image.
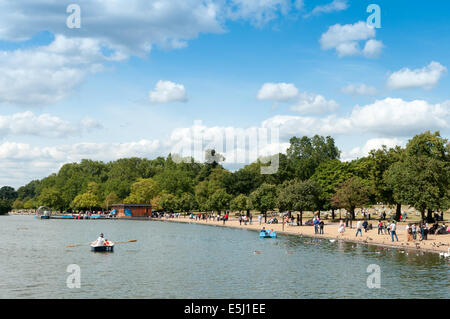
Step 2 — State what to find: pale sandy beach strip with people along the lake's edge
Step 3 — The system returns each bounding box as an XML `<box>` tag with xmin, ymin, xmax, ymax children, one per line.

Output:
<box><xmin>158</xmin><ymin>216</ymin><xmax>450</xmax><ymax>253</ymax></box>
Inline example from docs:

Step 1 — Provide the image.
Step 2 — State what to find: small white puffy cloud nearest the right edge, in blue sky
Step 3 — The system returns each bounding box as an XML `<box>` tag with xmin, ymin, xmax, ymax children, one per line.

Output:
<box><xmin>387</xmin><ymin>61</ymin><xmax>447</xmax><ymax>89</ymax></box>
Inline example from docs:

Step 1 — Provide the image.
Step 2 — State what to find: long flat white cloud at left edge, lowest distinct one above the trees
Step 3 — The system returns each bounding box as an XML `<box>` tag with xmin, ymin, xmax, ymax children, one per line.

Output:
<box><xmin>0</xmin><ymin>111</ymin><xmax>102</xmax><ymax>138</ymax></box>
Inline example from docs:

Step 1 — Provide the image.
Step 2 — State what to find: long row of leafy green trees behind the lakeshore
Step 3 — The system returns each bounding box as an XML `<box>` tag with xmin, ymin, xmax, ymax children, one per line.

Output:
<box><xmin>0</xmin><ymin>131</ymin><xmax>450</xmax><ymax>219</ymax></box>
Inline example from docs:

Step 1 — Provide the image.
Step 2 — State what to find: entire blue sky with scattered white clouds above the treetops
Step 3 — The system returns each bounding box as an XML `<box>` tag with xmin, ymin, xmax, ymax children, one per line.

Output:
<box><xmin>0</xmin><ymin>0</ymin><xmax>450</xmax><ymax>187</ymax></box>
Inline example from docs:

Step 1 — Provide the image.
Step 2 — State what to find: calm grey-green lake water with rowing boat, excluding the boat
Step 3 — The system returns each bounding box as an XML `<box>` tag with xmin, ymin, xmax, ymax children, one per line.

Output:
<box><xmin>0</xmin><ymin>216</ymin><xmax>450</xmax><ymax>299</ymax></box>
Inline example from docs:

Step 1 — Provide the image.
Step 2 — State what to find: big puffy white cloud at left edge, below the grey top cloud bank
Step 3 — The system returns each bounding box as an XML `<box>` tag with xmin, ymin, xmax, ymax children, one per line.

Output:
<box><xmin>0</xmin><ymin>35</ymin><xmax>108</xmax><ymax>107</ymax></box>
